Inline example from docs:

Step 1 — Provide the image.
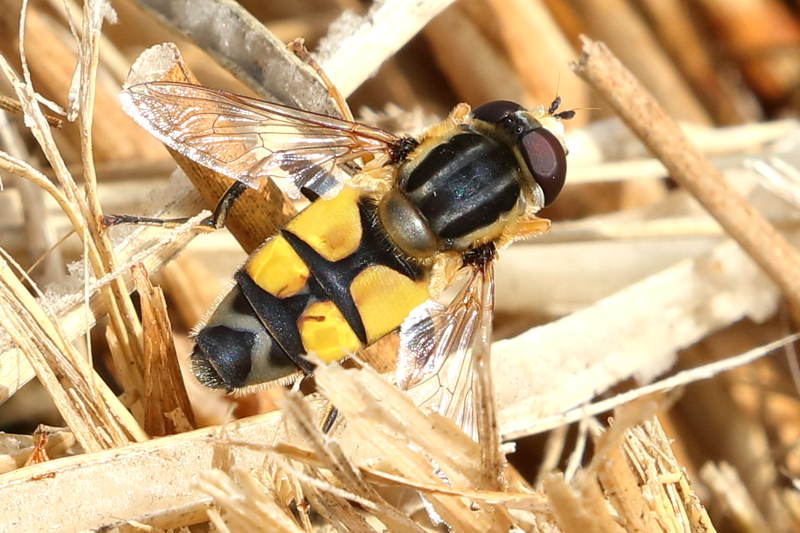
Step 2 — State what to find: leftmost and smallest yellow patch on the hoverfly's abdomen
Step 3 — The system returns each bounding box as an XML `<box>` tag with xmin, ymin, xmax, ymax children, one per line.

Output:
<box><xmin>246</xmin><ymin>235</ymin><xmax>310</xmax><ymax>298</ymax></box>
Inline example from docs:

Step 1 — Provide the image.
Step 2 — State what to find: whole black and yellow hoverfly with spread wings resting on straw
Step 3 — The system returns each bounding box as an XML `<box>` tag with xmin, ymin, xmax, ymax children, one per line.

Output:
<box><xmin>112</xmin><ymin>70</ymin><xmax>574</xmax><ymax>434</ymax></box>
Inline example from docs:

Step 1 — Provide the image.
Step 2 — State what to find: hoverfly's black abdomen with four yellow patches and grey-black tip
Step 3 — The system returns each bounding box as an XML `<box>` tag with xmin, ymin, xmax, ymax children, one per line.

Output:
<box><xmin>192</xmin><ymin>187</ymin><xmax>428</xmax><ymax>390</ymax></box>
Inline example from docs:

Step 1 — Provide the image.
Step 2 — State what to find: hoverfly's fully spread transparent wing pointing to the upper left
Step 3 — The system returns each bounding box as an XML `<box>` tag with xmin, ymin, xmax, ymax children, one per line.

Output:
<box><xmin>120</xmin><ymin>82</ymin><xmax>398</xmax><ymax>196</ymax></box>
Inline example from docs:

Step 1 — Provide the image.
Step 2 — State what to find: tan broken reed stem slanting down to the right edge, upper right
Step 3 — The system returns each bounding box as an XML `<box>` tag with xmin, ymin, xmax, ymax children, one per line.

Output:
<box><xmin>572</xmin><ymin>36</ymin><xmax>800</xmax><ymax>307</ymax></box>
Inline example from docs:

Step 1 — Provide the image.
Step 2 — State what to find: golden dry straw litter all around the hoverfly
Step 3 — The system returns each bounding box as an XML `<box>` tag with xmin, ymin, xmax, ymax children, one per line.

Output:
<box><xmin>0</xmin><ymin>0</ymin><xmax>800</xmax><ymax>533</ymax></box>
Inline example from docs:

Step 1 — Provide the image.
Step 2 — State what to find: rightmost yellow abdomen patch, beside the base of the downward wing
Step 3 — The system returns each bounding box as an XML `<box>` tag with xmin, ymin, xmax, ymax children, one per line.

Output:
<box><xmin>350</xmin><ymin>265</ymin><xmax>429</xmax><ymax>343</ymax></box>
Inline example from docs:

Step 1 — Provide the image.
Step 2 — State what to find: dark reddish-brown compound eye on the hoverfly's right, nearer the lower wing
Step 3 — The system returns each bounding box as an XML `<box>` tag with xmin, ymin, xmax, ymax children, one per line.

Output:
<box><xmin>519</xmin><ymin>128</ymin><xmax>567</xmax><ymax>206</ymax></box>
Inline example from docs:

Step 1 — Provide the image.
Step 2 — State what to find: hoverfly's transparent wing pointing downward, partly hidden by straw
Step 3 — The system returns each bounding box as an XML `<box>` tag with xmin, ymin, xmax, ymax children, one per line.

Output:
<box><xmin>396</xmin><ymin>262</ymin><xmax>494</xmax><ymax>439</ymax></box>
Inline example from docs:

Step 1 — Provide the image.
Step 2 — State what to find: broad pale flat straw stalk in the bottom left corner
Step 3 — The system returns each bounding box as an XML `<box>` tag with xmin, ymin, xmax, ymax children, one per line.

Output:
<box><xmin>0</xmin><ymin>413</ymin><xmax>280</xmax><ymax>532</ymax></box>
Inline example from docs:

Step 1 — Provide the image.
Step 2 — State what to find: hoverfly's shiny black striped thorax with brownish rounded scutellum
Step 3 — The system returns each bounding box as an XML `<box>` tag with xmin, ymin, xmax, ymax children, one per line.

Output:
<box><xmin>379</xmin><ymin>128</ymin><xmax>521</xmax><ymax>258</ymax></box>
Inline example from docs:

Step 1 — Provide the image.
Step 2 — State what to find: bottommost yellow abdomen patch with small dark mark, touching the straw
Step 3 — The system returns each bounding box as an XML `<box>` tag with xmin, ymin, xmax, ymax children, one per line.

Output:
<box><xmin>297</xmin><ymin>302</ymin><xmax>361</xmax><ymax>363</ymax></box>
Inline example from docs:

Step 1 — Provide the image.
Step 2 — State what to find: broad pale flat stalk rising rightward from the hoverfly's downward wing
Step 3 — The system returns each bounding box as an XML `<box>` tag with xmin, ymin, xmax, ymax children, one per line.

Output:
<box><xmin>492</xmin><ymin>235</ymin><xmax>777</xmax><ymax>438</ymax></box>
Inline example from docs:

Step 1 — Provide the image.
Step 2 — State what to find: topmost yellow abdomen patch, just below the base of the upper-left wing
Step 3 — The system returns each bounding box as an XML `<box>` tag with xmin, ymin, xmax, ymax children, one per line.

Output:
<box><xmin>286</xmin><ymin>187</ymin><xmax>362</xmax><ymax>261</ymax></box>
